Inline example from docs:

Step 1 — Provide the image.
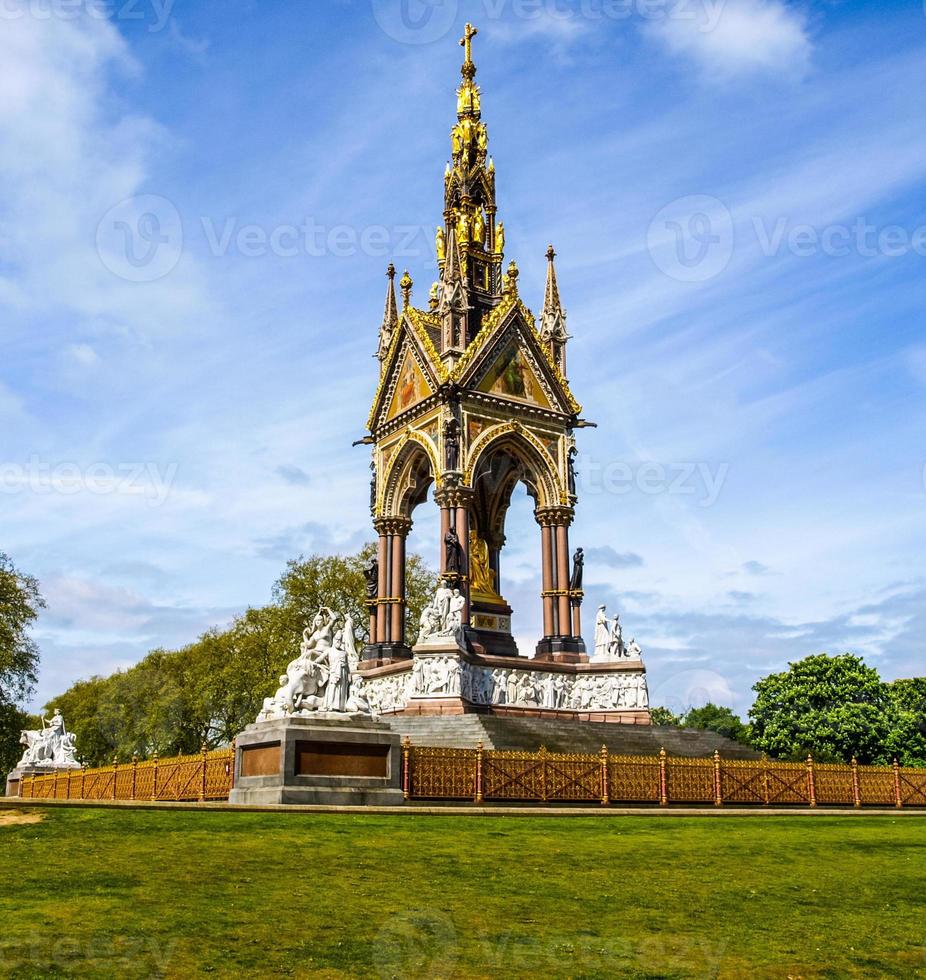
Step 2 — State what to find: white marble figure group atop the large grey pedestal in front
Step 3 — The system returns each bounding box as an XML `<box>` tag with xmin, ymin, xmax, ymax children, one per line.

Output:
<box><xmin>257</xmin><ymin>606</ymin><xmax>371</xmax><ymax>721</ymax></box>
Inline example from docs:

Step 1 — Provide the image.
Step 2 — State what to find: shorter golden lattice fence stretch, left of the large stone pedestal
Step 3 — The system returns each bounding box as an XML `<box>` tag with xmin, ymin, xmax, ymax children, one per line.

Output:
<box><xmin>19</xmin><ymin>746</ymin><xmax>235</xmax><ymax>802</ymax></box>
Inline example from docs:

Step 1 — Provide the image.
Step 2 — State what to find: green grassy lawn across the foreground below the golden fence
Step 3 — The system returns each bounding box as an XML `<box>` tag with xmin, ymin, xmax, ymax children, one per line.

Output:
<box><xmin>0</xmin><ymin>809</ymin><xmax>926</xmax><ymax>978</ymax></box>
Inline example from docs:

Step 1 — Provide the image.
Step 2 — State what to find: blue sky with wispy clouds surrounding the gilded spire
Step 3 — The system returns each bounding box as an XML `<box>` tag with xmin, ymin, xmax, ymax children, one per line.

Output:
<box><xmin>0</xmin><ymin>0</ymin><xmax>926</xmax><ymax>710</ymax></box>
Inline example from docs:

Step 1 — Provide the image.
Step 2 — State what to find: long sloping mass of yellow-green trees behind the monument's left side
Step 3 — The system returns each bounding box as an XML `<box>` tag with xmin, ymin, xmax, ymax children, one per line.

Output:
<box><xmin>42</xmin><ymin>544</ymin><xmax>437</xmax><ymax>765</ymax></box>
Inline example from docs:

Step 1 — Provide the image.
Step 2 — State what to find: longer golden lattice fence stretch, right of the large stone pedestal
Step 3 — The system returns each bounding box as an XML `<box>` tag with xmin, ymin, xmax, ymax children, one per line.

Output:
<box><xmin>403</xmin><ymin>739</ymin><xmax>926</xmax><ymax>807</ymax></box>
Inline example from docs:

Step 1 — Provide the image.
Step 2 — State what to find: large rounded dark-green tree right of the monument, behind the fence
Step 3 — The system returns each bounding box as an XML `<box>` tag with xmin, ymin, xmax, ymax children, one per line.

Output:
<box><xmin>749</xmin><ymin>653</ymin><xmax>889</xmax><ymax>763</ymax></box>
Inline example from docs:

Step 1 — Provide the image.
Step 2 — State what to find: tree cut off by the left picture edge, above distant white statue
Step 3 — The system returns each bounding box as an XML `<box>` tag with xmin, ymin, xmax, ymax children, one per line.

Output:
<box><xmin>0</xmin><ymin>552</ymin><xmax>45</xmax><ymax>769</ymax></box>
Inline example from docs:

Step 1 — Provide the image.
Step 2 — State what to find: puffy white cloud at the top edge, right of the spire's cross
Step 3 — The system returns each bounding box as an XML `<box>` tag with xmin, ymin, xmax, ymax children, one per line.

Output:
<box><xmin>650</xmin><ymin>0</ymin><xmax>812</xmax><ymax>80</ymax></box>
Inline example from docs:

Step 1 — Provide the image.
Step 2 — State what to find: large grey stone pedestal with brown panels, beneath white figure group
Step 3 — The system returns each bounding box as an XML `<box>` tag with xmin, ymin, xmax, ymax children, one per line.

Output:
<box><xmin>229</xmin><ymin>712</ymin><xmax>403</xmax><ymax>806</ymax></box>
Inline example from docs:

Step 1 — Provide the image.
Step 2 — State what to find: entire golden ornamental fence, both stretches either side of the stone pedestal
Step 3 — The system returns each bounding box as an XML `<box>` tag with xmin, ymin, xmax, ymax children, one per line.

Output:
<box><xmin>12</xmin><ymin>739</ymin><xmax>926</xmax><ymax>807</ymax></box>
